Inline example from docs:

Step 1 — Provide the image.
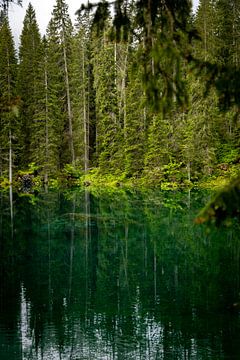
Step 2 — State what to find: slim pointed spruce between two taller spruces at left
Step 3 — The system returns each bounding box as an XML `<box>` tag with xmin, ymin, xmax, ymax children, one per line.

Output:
<box><xmin>31</xmin><ymin>37</ymin><xmax>62</xmax><ymax>183</ymax></box>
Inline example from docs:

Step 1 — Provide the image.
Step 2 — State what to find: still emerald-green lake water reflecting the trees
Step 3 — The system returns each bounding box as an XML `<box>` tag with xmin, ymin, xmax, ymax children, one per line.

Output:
<box><xmin>0</xmin><ymin>191</ymin><xmax>240</xmax><ymax>360</ymax></box>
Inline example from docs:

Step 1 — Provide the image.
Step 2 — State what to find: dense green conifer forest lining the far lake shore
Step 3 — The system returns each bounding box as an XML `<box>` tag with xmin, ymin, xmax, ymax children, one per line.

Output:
<box><xmin>0</xmin><ymin>0</ymin><xmax>240</xmax><ymax>186</ymax></box>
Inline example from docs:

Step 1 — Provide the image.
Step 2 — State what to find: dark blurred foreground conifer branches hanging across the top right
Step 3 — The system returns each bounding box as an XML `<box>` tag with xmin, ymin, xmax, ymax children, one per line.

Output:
<box><xmin>77</xmin><ymin>0</ymin><xmax>240</xmax><ymax>110</ymax></box>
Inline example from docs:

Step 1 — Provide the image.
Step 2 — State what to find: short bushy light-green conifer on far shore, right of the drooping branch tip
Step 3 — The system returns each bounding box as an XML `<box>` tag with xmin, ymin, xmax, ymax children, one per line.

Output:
<box><xmin>179</xmin><ymin>78</ymin><xmax>221</xmax><ymax>180</ymax></box>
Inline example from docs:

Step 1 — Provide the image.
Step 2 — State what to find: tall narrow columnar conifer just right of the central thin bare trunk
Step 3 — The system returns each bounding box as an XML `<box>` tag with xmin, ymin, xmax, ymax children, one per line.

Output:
<box><xmin>92</xmin><ymin>21</ymin><xmax>123</xmax><ymax>172</ymax></box>
